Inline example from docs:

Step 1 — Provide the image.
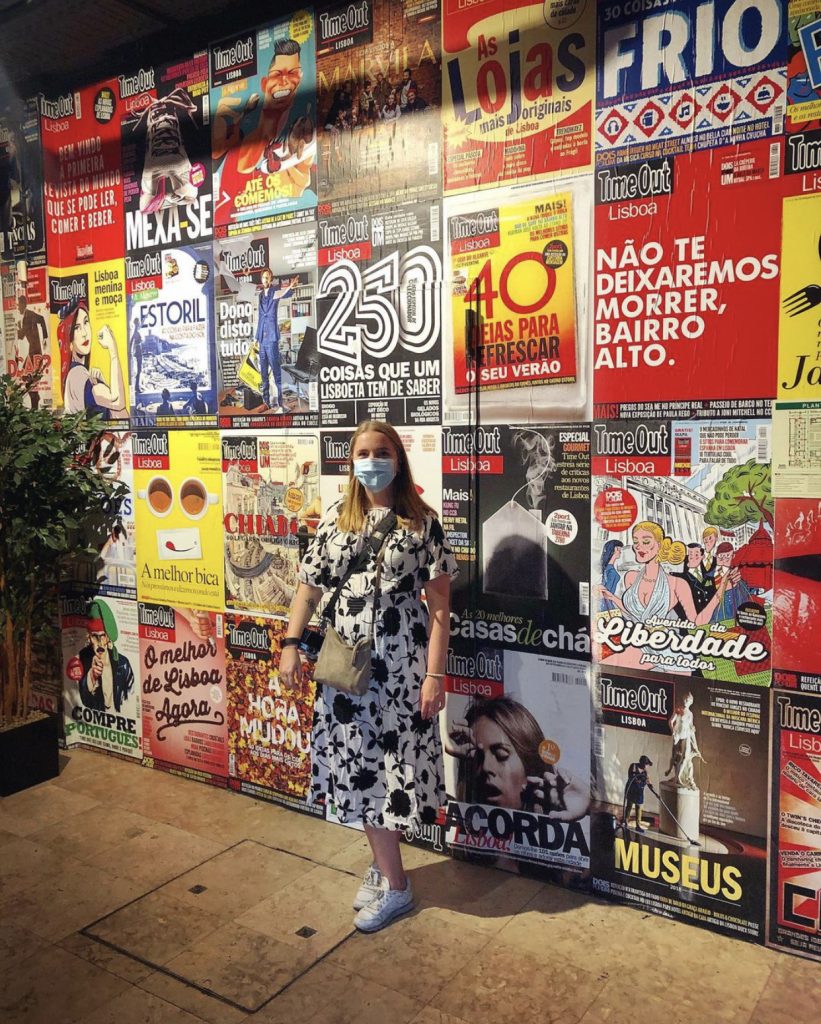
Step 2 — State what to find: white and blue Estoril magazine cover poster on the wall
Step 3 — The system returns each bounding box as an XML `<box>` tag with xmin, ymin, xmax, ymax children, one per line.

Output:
<box><xmin>126</xmin><ymin>245</ymin><xmax>217</xmax><ymax>427</ymax></box>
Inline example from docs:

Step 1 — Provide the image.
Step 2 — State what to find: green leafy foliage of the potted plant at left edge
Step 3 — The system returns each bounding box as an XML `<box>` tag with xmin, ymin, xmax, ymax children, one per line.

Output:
<box><xmin>0</xmin><ymin>375</ymin><xmax>124</xmax><ymax>725</ymax></box>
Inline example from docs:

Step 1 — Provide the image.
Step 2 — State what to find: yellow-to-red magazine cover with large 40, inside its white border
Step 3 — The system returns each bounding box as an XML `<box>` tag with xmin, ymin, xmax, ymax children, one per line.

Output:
<box><xmin>447</xmin><ymin>193</ymin><xmax>576</xmax><ymax>394</ymax></box>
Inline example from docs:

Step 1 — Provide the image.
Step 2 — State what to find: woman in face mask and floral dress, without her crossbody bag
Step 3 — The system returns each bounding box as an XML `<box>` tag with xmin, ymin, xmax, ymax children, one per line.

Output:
<box><xmin>279</xmin><ymin>421</ymin><xmax>458</xmax><ymax>932</ymax></box>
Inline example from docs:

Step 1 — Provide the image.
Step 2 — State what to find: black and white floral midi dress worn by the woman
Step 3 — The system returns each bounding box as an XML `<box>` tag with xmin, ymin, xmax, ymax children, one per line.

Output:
<box><xmin>299</xmin><ymin>503</ymin><xmax>459</xmax><ymax>829</ymax></box>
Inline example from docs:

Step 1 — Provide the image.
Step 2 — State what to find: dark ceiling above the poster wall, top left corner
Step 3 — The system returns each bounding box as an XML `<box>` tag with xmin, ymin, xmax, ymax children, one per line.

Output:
<box><xmin>0</xmin><ymin>0</ymin><xmax>300</xmax><ymax>98</ymax></box>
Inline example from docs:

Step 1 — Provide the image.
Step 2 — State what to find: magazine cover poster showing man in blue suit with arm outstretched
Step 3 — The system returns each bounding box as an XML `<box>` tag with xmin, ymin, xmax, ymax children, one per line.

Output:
<box><xmin>214</xmin><ymin>220</ymin><xmax>319</xmax><ymax>428</ymax></box>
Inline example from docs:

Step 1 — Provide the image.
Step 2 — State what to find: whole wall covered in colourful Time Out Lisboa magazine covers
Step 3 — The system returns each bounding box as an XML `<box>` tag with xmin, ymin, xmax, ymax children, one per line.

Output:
<box><xmin>0</xmin><ymin>0</ymin><xmax>821</xmax><ymax>958</ymax></box>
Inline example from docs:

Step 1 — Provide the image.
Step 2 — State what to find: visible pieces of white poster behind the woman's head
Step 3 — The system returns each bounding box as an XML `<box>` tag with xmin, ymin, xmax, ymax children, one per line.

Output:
<box><xmin>319</xmin><ymin>427</ymin><xmax>442</xmax><ymax>520</ymax></box>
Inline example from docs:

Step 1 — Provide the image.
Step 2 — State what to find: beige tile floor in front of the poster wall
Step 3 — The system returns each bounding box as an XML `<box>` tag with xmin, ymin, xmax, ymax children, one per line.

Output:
<box><xmin>0</xmin><ymin>751</ymin><xmax>821</xmax><ymax>1024</ymax></box>
